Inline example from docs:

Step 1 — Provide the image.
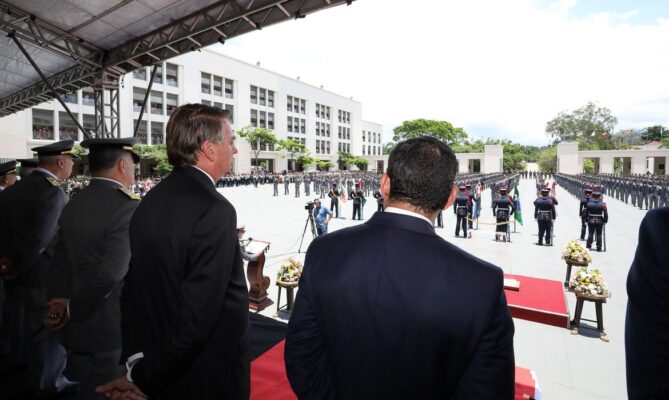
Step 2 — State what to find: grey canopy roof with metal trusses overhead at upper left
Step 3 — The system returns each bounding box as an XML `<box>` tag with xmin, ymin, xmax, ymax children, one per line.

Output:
<box><xmin>0</xmin><ymin>0</ymin><xmax>344</xmax><ymax>117</ymax></box>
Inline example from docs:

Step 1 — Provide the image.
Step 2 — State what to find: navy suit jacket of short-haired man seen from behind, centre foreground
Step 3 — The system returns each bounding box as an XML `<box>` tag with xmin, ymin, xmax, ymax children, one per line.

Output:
<box><xmin>285</xmin><ymin>213</ymin><xmax>515</xmax><ymax>400</ymax></box>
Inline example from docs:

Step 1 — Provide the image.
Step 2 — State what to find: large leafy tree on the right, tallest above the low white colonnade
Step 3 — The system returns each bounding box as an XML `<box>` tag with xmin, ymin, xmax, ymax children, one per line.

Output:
<box><xmin>546</xmin><ymin>102</ymin><xmax>618</xmax><ymax>150</ymax></box>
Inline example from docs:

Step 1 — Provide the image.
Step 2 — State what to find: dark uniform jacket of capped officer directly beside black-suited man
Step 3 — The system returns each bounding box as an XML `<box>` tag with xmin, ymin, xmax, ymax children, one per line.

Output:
<box><xmin>47</xmin><ymin>179</ymin><xmax>139</xmax><ymax>353</ymax></box>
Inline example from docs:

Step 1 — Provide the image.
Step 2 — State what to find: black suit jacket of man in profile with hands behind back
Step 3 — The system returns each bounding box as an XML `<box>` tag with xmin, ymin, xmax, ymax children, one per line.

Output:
<box><xmin>121</xmin><ymin>167</ymin><xmax>250</xmax><ymax>399</ymax></box>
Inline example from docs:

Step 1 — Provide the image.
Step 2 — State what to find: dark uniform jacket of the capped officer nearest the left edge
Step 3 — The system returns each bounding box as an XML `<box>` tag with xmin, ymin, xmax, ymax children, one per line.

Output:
<box><xmin>0</xmin><ymin>170</ymin><xmax>67</xmax><ymax>288</ymax></box>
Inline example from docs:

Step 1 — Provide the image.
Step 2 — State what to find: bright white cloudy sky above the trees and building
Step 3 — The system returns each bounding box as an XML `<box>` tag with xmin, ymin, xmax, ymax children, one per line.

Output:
<box><xmin>217</xmin><ymin>0</ymin><xmax>669</xmax><ymax>145</ymax></box>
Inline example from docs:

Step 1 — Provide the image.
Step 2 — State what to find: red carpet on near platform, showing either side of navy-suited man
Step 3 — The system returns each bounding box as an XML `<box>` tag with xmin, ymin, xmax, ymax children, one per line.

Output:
<box><xmin>251</xmin><ymin>340</ymin><xmax>539</xmax><ymax>400</ymax></box>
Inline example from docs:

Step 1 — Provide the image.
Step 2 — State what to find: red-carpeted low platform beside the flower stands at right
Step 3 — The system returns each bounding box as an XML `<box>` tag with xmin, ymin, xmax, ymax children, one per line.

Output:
<box><xmin>504</xmin><ymin>275</ymin><xmax>569</xmax><ymax>328</ymax></box>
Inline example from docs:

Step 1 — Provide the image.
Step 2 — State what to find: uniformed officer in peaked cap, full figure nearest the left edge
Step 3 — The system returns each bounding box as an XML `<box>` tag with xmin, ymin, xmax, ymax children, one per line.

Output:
<box><xmin>0</xmin><ymin>140</ymin><xmax>77</xmax><ymax>396</ymax></box>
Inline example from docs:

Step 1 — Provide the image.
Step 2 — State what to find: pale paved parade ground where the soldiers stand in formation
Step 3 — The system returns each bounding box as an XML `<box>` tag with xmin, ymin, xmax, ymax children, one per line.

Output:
<box><xmin>219</xmin><ymin>179</ymin><xmax>646</xmax><ymax>399</ymax></box>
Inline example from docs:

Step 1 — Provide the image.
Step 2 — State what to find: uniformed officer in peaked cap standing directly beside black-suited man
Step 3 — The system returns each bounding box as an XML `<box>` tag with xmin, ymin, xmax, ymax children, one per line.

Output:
<box><xmin>45</xmin><ymin>138</ymin><xmax>139</xmax><ymax>399</ymax></box>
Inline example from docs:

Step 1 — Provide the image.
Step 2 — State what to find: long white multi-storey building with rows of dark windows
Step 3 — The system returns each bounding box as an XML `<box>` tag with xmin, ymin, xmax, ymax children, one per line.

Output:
<box><xmin>0</xmin><ymin>49</ymin><xmax>383</xmax><ymax>173</ymax></box>
